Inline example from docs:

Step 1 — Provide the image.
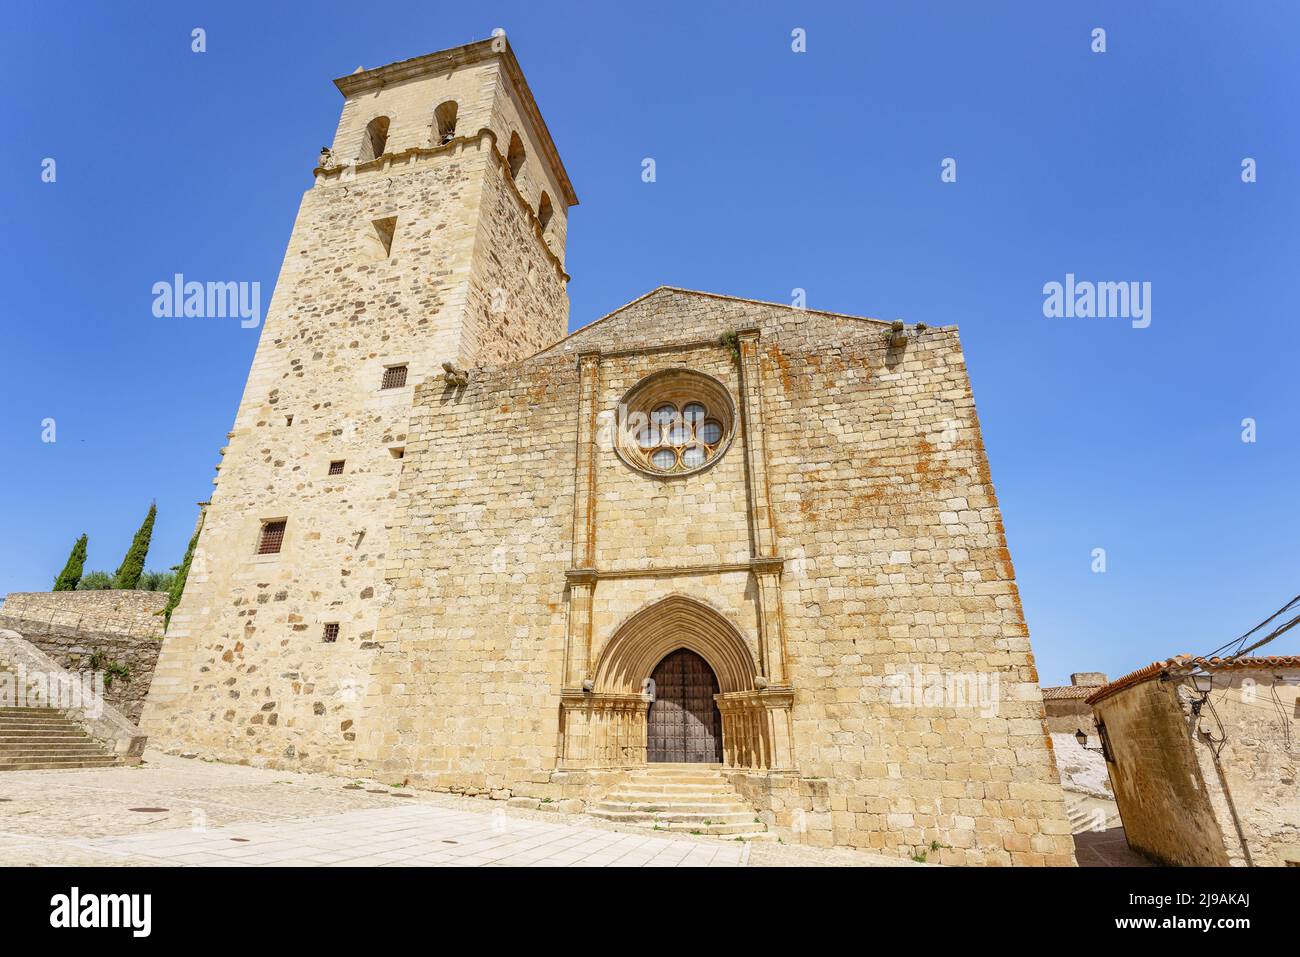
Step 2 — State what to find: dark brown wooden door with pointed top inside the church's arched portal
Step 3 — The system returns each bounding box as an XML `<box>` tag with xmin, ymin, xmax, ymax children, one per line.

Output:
<box><xmin>646</xmin><ymin>648</ymin><xmax>723</xmax><ymax>763</ymax></box>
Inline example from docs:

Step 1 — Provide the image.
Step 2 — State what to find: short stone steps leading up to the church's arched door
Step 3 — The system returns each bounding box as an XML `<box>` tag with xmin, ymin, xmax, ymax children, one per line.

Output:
<box><xmin>586</xmin><ymin>765</ymin><xmax>776</xmax><ymax>841</ymax></box>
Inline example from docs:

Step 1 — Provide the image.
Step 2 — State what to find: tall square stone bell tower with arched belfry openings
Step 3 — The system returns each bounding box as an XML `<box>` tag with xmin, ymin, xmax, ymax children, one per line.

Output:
<box><xmin>142</xmin><ymin>36</ymin><xmax>577</xmax><ymax>767</ymax></box>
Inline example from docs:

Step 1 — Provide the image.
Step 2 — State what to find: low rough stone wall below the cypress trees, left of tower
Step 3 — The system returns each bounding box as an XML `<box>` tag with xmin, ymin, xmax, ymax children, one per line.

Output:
<box><xmin>0</xmin><ymin>590</ymin><xmax>168</xmax><ymax>722</ymax></box>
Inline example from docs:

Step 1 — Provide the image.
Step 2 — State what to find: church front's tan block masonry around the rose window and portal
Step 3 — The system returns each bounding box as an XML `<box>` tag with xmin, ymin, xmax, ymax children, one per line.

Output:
<box><xmin>361</xmin><ymin>290</ymin><xmax>1073</xmax><ymax>863</ymax></box>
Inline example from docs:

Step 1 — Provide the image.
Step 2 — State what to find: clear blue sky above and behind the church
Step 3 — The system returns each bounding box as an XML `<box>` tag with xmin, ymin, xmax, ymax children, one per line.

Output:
<box><xmin>0</xmin><ymin>0</ymin><xmax>1300</xmax><ymax>683</ymax></box>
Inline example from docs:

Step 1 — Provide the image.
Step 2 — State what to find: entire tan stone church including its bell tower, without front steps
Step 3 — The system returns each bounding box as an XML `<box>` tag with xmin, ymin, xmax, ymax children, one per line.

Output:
<box><xmin>142</xmin><ymin>38</ymin><xmax>1074</xmax><ymax>865</ymax></box>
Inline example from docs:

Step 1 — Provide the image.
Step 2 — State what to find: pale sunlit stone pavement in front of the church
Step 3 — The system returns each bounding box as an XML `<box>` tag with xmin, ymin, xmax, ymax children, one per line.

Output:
<box><xmin>0</xmin><ymin>752</ymin><xmax>911</xmax><ymax>867</ymax></box>
